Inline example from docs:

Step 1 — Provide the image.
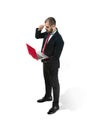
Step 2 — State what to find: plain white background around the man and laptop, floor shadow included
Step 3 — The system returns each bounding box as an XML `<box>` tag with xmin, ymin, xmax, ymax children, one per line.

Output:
<box><xmin>0</xmin><ymin>0</ymin><xmax>87</xmax><ymax>130</ymax></box>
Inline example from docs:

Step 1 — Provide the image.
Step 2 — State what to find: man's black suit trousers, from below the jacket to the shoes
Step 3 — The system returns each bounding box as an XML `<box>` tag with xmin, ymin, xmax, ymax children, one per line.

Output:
<box><xmin>43</xmin><ymin>61</ymin><xmax>60</xmax><ymax>105</ymax></box>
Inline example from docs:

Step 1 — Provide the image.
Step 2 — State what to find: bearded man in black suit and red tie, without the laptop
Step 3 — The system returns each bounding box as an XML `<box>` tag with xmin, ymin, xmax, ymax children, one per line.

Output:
<box><xmin>35</xmin><ymin>17</ymin><xmax>64</xmax><ymax>114</ymax></box>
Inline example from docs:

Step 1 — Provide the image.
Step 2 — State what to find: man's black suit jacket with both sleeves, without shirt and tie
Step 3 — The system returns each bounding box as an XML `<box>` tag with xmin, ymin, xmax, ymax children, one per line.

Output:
<box><xmin>35</xmin><ymin>28</ymin><xmax>64</xmax><ymax>66</ymax></box>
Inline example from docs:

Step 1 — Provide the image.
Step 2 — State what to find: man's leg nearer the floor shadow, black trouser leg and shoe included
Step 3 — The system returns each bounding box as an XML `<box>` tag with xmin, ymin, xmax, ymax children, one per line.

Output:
<box><xmin>48</xmin><ymin>64</ymin><xmax>60</xmax><ymax>114</ymax></box>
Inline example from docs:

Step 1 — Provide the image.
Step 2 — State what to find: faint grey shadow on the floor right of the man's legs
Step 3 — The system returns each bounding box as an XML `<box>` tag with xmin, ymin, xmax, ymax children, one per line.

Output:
<box><xmin>60</xmin><ymin>87</ymin><xmax>86</xmax><ymax>110</ymax></box>
